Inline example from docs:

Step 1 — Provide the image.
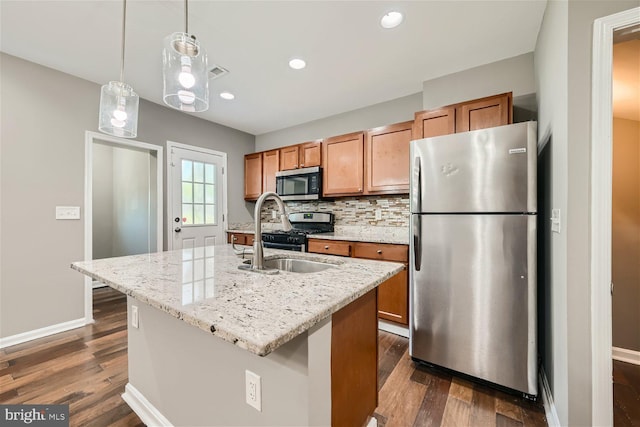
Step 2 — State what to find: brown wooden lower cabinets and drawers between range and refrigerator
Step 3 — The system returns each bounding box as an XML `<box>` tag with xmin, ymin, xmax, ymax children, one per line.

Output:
<box><xmin>307</xmin><ymin>239</ymin><xmax>409</xmax><ymax>325</ymax></box>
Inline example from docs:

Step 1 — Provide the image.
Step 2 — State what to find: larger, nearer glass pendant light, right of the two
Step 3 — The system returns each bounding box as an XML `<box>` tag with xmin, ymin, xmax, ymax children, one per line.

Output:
<box><xmin>162</xmin><ymin>0</ymin><xmax>209</xmax><ymax>112</ymax></box>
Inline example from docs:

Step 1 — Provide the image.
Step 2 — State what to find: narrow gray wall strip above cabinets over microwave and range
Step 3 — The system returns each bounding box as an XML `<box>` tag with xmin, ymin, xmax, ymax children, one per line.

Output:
<box><xmin>256</xmin><ymin>93</ymin><xmax>422</xmax><ymax>151</ymax></box>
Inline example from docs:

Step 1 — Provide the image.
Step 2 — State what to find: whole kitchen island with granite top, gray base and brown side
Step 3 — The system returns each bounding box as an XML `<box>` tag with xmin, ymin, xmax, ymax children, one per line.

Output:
<box><xmin>72</xmin><ymin>245</ymin><xmax>404</xmax><ymax>426</ymax></box>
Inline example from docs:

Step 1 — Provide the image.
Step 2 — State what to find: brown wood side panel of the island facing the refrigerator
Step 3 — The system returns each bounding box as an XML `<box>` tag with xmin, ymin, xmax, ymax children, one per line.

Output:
<box><xmin>331</xmin><ymin>288</ymin><xmax>378</xmax><ymax>427</ymax></box>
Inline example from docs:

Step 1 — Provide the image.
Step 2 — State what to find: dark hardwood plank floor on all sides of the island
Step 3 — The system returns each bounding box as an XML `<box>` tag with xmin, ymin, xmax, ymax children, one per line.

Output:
<box><xmin>0</xmin><ymin>288</ymin><xmax>552</xmax><ymax>427</ymax></box>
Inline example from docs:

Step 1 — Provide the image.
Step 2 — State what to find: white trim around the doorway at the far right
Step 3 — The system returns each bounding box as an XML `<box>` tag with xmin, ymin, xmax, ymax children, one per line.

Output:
<box><xmin>591</xmin><ymin>7</ymin><xmax>640</xmax><ymax>425</ymax></box>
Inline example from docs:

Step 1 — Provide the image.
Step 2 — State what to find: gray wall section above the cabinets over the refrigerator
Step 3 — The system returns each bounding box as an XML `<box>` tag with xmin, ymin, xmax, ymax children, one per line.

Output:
<box><xmin>422</xmin><ymin>52</ymin><xmax>536</xmax><ymax>110</ymax></box>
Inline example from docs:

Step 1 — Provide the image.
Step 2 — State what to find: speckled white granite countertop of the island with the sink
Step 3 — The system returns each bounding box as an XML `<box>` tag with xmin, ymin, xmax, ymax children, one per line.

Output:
<box><xmin>71</xmin><ymin>245</ymin><xmax>404</xmax><ymax>356</ymax></box>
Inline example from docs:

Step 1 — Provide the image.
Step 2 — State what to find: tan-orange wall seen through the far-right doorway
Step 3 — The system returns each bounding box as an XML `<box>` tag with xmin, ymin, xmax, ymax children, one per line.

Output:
<box><xmin>611</xmin><ymin>117</ymin><xmax>640</xmax><ymax>351</ymax></box>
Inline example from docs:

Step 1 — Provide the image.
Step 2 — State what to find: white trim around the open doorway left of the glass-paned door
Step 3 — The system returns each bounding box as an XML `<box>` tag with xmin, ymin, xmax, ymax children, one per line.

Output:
<box><xmin>84</xmin><ymin>131</ymin><xmax>164</xmax><ymax>324</ymax></box>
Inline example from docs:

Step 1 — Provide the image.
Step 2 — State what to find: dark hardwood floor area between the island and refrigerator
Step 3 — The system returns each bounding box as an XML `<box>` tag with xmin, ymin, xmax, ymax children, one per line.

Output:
<box><xmin>375</xmin><ymin>331</ymin><xmax>547</xmax><ymax>427</ymax></box>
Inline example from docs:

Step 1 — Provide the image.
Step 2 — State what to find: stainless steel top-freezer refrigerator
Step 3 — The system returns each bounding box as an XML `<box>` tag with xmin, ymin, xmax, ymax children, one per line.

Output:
<box><xmin>410</xmin><ymin>122</ymin><xmax>538</xmax><ymax>395</ymax></box>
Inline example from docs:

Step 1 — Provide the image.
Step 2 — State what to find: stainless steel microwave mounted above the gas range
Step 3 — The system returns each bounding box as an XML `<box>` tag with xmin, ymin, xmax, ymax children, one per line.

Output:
<box><xmin>276</xmin><ymin>166</ymin><xmax>322</xmax><ymax>200</ymax></box>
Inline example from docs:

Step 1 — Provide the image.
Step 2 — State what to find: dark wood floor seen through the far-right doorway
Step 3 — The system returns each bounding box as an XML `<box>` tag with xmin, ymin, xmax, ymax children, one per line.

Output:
<box><xmin>613</xmin><ymin>360</ymin><xmax>640</xmax><ymax>427</ymax></box>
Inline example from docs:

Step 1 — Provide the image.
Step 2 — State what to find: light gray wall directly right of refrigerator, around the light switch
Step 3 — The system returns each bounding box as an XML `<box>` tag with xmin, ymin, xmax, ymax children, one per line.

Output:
<box><xmin>534</xmin><ymin>1</ymin><xmax>569</xmax><ymax>425</ymax></box>
